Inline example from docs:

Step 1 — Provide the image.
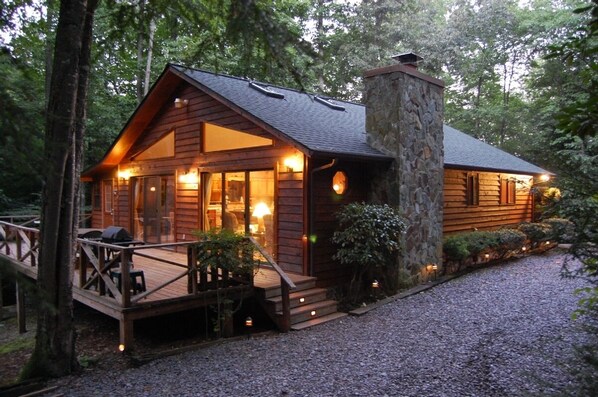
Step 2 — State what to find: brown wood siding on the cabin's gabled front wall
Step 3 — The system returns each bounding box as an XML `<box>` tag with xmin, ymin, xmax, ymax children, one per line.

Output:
<box><xmin>93</xmin><ymin>83</ymin><xmax>305</xmax><ymax>273</ymax></box>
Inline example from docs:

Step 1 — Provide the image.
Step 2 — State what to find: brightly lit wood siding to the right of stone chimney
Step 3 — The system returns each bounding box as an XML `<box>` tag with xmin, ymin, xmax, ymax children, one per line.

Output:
<box><xmin>443</xmin><ymin>169</ymin><xmax>533</xmax><ymax>234</ymax></box>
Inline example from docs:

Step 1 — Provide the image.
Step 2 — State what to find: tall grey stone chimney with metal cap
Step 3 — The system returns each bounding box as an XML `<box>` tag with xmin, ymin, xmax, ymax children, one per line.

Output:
<box><xmin>365</xmin><ymin>53</ymin><xmax>444</xmax><ymax>274</ymax></box>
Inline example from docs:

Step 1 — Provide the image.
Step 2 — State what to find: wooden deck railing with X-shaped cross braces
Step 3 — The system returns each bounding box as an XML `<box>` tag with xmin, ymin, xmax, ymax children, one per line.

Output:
<box><xmin>0</xmin><ymin>221</ymin><xmax>296</xmax><ymax>332</ymax></box>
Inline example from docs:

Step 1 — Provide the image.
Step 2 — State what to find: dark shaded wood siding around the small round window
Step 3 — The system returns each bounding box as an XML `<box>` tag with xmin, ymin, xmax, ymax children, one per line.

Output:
<box><xmin>311</xmin><ymin>161</ymin><xmax>369</xmax><ymax>287</ymax></box>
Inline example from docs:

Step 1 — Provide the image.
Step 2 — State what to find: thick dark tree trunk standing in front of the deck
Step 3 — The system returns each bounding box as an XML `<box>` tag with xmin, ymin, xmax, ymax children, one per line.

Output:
<box><xmin>23</xmin><ymin>0</ymin><xmax>98</xmax><ymax>378</ymax></box>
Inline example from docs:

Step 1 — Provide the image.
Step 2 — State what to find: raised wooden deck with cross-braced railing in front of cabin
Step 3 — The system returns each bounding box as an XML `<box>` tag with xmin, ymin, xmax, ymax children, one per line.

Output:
<box><xmin>0</xmin><ymin>222</ymin><xmax>304</xmax><ymax>347</ymax></box>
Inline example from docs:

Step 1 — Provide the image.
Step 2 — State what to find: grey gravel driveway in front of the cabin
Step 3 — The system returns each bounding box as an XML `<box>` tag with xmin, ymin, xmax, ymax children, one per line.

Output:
<box><xmin>51</xmin><ymin>251</ymin><xmax>582</xmax><ymax>397</ymax></box>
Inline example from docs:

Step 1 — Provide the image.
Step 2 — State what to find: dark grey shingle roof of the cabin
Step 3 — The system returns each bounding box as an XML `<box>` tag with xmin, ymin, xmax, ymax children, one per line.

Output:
<box><xmin>171</xmin><ymin>65</ymin><xmax>547</xmax><ymax>174</ymax></box>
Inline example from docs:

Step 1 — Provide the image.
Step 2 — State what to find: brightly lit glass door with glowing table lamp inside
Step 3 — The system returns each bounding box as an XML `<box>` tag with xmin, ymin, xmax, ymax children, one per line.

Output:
<box><xmin>201</xmin><ymin>170</ymin><xmax>274</xmax><ymax>253</ymax></box>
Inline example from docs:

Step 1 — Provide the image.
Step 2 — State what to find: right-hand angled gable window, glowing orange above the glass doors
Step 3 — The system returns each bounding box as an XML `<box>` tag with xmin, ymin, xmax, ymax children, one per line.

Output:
<box><xmin>203</xmin><ymin>123</ymin><xmax>273</xmax><ymax>153</ymax></box>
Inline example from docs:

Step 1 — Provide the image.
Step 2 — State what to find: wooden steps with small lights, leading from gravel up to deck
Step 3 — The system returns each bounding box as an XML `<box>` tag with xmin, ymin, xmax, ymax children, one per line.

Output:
<box><xmin>258</xmin><ymin>277</ymin><xmax>347</xmax><ymax>331</ymax></box>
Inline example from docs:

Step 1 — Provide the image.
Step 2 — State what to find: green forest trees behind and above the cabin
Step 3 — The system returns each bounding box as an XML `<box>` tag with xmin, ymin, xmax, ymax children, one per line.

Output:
<box><xmin>0</xmin><ymin>0</ymin><xmax>596</xmax><ymax>212</ymax></box>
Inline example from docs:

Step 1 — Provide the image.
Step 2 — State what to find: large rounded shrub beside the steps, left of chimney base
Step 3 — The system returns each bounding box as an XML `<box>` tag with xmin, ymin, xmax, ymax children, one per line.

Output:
<box><xmin>332</xmin><ymin>203</ymin><xmax>407</xmax><ymax>299</ymax></box>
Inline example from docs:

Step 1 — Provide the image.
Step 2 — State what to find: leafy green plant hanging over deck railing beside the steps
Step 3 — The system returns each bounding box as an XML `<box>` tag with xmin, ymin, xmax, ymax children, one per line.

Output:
<box><xmin>194</xmin><ymin>229</ymin><xmax>259</xmax><ymax>274</ymax></box>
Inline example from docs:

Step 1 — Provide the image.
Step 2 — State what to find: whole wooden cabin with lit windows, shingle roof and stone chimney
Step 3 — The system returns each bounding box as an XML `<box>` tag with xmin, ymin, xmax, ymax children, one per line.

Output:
<box><xmin>82</xmin><ymin>54</ymin><xmax>549</xmax><ymax>286</ymax></box>
